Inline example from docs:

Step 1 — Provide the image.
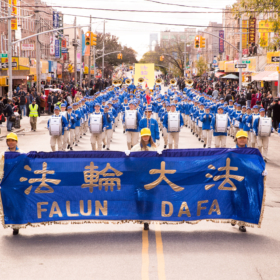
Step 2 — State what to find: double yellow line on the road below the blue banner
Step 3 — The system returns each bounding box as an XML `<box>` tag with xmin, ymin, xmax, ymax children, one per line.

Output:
<box><xmin>141</xmin><ymin>224</ymin><xmax>166</xmax><ymax>280</ymax></box>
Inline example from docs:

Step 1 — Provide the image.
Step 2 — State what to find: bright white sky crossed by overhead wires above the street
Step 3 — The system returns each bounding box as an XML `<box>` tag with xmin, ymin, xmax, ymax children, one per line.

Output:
<box><xmin>46</xmin><ymin>0</ymin><xmax>236</xmax><ymax>60</ymax></box>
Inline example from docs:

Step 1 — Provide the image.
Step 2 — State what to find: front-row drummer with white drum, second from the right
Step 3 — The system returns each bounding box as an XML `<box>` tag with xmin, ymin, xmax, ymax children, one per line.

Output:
<box><xmin>211</xmin><ymin>107</ymin><xmax>230</xmax><ymax>148</ymax></box>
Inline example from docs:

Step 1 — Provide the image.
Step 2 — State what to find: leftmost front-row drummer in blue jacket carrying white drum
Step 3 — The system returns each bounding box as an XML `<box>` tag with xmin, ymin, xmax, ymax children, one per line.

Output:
<box><xmin>48</xmin><ymin>106</ymin><xmax>68</xmax><ymax>152</ymax></box>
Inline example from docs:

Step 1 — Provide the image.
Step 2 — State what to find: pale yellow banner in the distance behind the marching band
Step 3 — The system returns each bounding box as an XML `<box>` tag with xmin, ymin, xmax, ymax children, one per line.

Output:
<box><xmin>134</xmin><ymin>63</ymin><xmax>155</xmax><ymax>89</ymax></box>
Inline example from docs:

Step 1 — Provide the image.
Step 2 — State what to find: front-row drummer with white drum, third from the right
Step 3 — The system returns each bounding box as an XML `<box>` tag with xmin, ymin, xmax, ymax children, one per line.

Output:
<box><xmin>163</xmin><ymin>103</ymin><xmax>184</xmax><ymax>149</ymax></box>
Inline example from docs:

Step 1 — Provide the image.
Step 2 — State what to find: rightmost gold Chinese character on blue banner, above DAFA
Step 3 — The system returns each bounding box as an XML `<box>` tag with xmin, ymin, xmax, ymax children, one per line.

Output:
<box><xmin>205</xmin><ymin>158</ymin><xmax>244</xmax><ymax>191</ymax></box>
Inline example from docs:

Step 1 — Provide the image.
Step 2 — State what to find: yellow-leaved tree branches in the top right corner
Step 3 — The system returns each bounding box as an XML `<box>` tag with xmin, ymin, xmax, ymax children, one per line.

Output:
<box><xmin>232</xmin><ymin>0</ymin><xmax>280</xmax><ymax>50</ymax></box>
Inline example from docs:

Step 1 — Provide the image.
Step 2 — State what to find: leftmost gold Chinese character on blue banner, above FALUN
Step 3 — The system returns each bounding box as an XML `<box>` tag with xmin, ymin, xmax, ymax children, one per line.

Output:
<box><xmin>19</xmin><ymin>162</ymin><xmax>61</xmax><ymax>195</ymax></box>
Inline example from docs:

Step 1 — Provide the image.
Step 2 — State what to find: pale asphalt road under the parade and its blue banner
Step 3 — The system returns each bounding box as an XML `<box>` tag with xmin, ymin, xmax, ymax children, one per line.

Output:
<box><xmin>0</xmin><ymin>90</ymin><xmax>280</xmax><ymax>280</ymax></box>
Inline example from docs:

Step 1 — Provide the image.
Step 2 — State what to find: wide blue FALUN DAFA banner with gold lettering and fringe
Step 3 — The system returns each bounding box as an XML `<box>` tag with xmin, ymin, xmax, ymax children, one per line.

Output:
<box><xmin>0</xmin><ymin>148</ymin><xmax>265</xmax><ymax>227</ymax></box>
